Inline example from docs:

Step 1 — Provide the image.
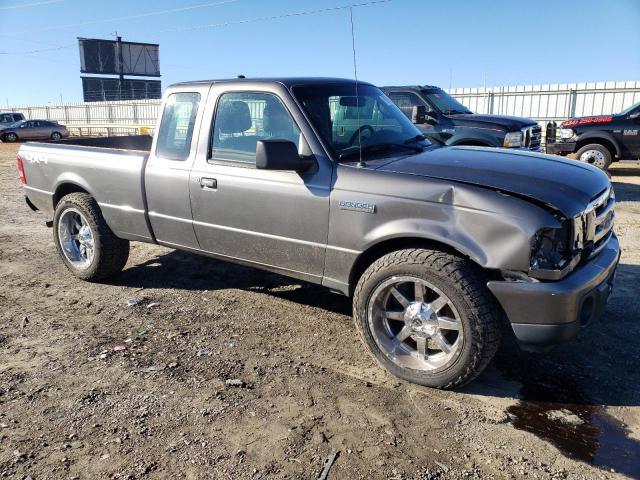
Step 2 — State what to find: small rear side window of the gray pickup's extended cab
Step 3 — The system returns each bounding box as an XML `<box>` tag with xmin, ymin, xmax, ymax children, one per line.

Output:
<box><xmin>156</xmin><ymin>93</ymin><xmax>200</xmax><ymax>160</ymax></box>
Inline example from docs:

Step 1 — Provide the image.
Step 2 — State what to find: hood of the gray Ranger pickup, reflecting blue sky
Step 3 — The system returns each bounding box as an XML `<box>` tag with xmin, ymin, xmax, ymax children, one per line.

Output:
<box><xmin>370</xmin><ymin>146</ymin><xmax>610</xmax><ymax>218</ymax></box>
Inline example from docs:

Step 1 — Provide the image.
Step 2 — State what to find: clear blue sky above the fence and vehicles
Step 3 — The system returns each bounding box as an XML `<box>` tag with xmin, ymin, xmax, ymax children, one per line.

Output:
<box><xmin>0</xmin><ymin>0</ymin><xmax>640</xmax><ymax>106</ymax></box>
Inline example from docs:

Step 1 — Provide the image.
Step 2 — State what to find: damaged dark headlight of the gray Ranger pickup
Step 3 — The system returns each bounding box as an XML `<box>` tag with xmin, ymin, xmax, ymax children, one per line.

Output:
<box><xmin>529</xmin><ymin>223</ymin><xmax>580</xmax><ymax>280</ymax></box>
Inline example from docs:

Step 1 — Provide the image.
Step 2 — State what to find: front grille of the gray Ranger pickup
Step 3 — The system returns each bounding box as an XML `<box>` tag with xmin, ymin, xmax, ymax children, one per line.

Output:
<box><xmin>575</xmin><ymin>187</ymin><xmax>616</xmax><ymax>258</ymax></box>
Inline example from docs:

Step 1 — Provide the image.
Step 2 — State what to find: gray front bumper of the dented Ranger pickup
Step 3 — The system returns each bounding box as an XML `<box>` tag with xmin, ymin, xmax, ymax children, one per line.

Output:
<box><xmin>487</xmin><ymin>234</ymin><xmax>620</xmax><ymax>350</ymax></box>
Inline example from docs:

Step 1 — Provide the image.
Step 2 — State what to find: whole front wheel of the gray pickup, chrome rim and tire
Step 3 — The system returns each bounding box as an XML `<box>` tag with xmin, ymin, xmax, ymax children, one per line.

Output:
<box><xmin>354</xmin><ymin>249</ymin><xmax>500</xmax><ymax>388</ymax></box>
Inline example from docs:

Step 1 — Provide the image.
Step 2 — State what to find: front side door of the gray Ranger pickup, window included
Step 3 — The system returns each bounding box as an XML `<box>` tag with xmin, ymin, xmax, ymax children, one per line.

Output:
<box><xmin>189</xmin><ymin>85</ymin><xmax>332</xmax><ymax>282</ymax></box>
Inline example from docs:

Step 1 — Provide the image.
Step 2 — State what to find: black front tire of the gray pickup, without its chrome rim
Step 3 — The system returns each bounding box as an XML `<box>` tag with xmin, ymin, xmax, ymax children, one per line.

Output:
<box><xmin>353</xmin><ymin>249</ymin><xmax>501</xmax><ymax>389</ymax></box>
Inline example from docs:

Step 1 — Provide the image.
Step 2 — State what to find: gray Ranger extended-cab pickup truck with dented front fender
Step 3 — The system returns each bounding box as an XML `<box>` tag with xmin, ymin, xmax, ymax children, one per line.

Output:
<box><xmin>18</xmin><ymin>78</ymin><xmax>620</xmax><ymax>388</ymax></box>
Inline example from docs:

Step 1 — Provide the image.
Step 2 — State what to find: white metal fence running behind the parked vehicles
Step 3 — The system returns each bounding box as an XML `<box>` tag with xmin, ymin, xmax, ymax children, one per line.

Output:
<box><xmin>2</xmin><ymin>81</ymin><xmax>640</xmax><ymax>139</ymax></box>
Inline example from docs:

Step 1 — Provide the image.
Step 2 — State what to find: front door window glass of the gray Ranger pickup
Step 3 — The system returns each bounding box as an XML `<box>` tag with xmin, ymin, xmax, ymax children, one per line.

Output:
<box><xmin>210</xmin><ymin>92</ymin><xmax>300</xmax><ymax>164</ymax></box>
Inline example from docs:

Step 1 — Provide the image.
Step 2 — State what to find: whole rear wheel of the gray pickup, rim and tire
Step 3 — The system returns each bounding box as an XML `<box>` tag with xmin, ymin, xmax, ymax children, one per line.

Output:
<box><xmin>53</xmin><ymin>193</ymin><xmax>129</xmax><ymax>281</ymax></box>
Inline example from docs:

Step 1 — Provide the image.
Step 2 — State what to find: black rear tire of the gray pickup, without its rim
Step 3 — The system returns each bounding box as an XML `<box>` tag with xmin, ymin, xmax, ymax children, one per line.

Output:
<box><xmin>53</xmin><ymin>192</ymin><xmax>129</xmax><ymax>281</ymax></box>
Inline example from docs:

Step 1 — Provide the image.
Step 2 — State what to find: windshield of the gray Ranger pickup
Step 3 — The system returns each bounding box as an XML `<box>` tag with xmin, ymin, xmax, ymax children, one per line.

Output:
<box><xmin>293</xmin><ymin>83</ymin><xmax>429</xmax><ymax>159</ymax></box>
